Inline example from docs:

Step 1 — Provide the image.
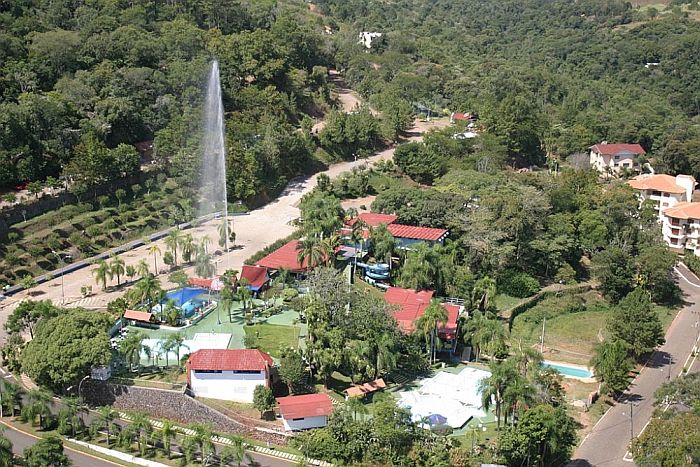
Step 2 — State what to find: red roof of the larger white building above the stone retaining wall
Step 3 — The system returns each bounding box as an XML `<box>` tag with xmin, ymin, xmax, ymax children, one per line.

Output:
<box><xmin>187</xmin><ymin>349</ymin><xmax>274</xmax><ymax>371</ymax></box>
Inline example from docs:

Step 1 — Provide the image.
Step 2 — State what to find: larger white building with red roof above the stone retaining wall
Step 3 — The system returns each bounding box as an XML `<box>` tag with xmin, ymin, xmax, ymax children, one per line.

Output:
<box><xmin>187</xmin><ymin>349</ymin><xmax>274</xmax><ymax>403</ymax></box>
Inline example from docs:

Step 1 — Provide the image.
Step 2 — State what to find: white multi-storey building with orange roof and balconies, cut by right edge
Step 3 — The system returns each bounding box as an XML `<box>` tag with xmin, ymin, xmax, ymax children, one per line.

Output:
<box><xmin>661</xmin><ymin>203</ymin><xmax>700</xmax><ymax>256</ymax></box>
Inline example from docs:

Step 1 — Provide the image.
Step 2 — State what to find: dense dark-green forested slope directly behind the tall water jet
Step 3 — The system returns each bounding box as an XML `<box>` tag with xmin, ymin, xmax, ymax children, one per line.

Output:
<box><xmin>0</xmin><ymin>0</ymin><xmax>331</xmax><ymax>194</ymax></box>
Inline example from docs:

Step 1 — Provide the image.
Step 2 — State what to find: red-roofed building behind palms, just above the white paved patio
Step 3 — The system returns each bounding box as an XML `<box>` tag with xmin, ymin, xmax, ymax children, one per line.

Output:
<box><xmin>384</xmin><ymin>287</ymin><xmax>459</xmax><ymax>340</ymax></box>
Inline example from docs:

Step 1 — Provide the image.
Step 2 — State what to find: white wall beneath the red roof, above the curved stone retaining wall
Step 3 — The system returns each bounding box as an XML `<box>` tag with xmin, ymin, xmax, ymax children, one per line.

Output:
<box><xmin>190</xmin><ymin>370</ymin><xmax>267</xmax><ymax>403</ymax></box>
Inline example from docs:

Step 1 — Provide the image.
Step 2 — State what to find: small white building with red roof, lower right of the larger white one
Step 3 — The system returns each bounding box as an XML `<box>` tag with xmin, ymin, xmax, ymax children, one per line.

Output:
<box><xmin>277</xmin><ymin>394</ymin><xmax>333</xmax><ymax>431</ymax></box>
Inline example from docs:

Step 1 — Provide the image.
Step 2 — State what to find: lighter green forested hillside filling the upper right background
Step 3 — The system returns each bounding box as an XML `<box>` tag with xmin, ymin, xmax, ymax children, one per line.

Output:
<box><xmin>318</xmin><ymin>0</ymin><xmax>700</xmax><ymax>170</ymax></box>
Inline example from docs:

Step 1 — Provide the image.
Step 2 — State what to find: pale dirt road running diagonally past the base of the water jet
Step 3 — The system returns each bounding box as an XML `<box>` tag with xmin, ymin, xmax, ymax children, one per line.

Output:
<box><xmin>0</xmin><ymin>84</ymin><xmax>449</xmax><ymax>326</ymax></box>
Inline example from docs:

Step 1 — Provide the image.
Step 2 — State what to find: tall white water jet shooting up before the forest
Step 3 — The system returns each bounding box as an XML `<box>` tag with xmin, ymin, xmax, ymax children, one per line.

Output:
<box><xmin>199</xmin><ymin>60</ymin><xmax>229</xmax><ymax>258</ymax></box>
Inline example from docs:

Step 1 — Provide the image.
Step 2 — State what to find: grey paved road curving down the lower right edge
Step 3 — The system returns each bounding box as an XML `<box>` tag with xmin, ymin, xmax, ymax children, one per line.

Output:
<box><xmin>569</xmin><ymin>265</ymin><xmax>700</xmax><ymax>467</ymax></box>
